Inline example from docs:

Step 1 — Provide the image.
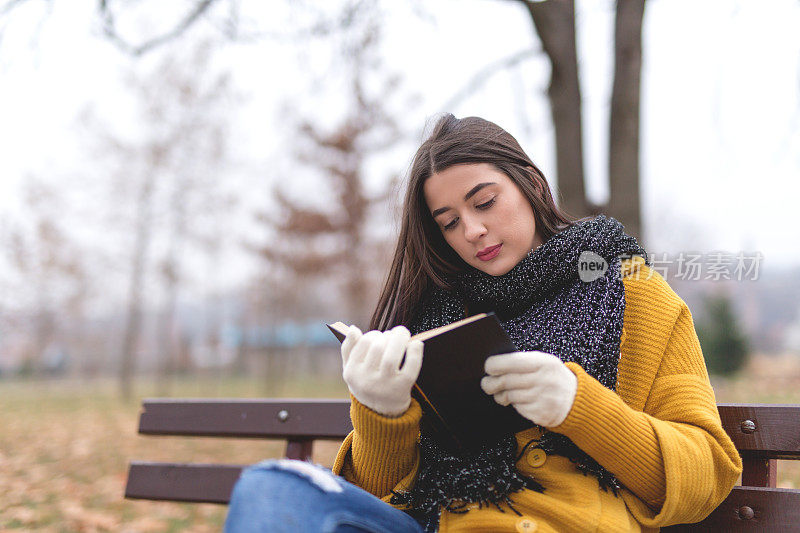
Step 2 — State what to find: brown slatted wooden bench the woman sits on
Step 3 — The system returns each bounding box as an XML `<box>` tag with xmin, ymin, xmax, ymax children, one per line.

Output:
<box><xmin>125</xmin><ymin>399</ymin><xmax>800</xmax><ymax>532</ymax></box>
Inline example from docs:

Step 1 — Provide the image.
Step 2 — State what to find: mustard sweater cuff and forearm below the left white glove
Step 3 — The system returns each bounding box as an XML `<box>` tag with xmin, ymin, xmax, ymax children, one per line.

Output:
<box><xmin>332</xmin><ymin>395</ymin><xmax>422</xmax><ymax>501</ymax></box>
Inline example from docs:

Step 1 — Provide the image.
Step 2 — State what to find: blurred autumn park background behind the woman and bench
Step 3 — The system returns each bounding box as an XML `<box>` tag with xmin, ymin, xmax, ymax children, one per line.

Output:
<box><xmin>0</xmin><ymin>0</ymin><xmax>800</xmax><ymax>531</ymax></box>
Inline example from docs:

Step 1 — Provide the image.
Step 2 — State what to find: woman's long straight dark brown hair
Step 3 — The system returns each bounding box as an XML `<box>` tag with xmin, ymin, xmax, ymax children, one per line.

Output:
<box><xmin>370</xmin><ymin>113</ymin><xmax>574</xmax><ymax>330</ymax></box>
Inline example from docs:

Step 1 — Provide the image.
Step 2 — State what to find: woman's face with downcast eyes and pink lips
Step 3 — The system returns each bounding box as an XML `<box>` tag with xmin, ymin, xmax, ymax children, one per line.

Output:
<box><xmin>423</xmin><ymin>163</ymin><xmax>542</xmax><ymax>276</ymax></box>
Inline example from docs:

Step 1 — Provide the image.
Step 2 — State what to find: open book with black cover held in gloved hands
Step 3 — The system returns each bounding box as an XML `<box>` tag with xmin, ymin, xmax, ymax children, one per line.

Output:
<box><xmin>328</xmin><ymin>313</ymin><xmax>533</xmax><ymax>448</ymax></box>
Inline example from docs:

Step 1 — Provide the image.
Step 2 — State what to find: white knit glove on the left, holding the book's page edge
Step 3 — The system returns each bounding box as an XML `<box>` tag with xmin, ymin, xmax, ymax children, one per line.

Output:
<box><xmin>342</xmin><ymin>326</ymin><xmax>423</xmax><ymax>417</ymax></box>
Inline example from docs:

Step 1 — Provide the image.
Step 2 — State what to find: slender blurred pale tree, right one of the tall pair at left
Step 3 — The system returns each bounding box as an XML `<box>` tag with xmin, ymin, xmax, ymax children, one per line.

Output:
<box><xmin>152</xmin><ymin>45</ymin><xmax>231</xmax><ymax>394</ymax></box>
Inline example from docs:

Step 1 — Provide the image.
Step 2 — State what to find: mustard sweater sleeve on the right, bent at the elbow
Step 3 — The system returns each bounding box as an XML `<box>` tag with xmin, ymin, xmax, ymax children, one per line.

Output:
<box><xmin>551</xmin><ymin>302</ymin><xmax>742</xmax><ymax>527</ymax></box>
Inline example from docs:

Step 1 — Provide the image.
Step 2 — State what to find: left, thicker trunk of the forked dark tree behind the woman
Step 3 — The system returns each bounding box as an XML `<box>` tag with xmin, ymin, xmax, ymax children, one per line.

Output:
<box><xmin>525</xmin><ymin>0</ymin><xmax>590</xmax><ymax>217</ymax></box>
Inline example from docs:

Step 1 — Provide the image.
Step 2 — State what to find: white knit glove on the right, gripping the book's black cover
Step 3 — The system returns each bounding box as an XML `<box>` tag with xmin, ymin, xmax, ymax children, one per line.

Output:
<box><xmin>481</xmin><ymin>352</ymin><xmax>578</xmax><ymax>427</ymax></box>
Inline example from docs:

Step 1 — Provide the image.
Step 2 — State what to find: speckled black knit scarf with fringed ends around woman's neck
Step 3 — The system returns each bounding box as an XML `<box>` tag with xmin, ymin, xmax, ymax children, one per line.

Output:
<box><xmin>392</xmin><ymin>215</ymin><xmax>647</xmax><ymax>531</ymax></box>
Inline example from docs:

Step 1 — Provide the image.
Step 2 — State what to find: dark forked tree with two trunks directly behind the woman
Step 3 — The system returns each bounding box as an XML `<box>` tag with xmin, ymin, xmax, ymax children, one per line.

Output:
<box><xmin>521</xmin><ymin>0</ymin><xmax>645</xmax><ymax>239</ymax></box>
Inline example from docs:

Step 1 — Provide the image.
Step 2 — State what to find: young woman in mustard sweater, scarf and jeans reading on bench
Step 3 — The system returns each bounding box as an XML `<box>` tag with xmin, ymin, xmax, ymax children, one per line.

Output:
<box><xmin>226</xmin><ymin>114</ymin><xmax>741</xmax><ymax>532</ymax></box>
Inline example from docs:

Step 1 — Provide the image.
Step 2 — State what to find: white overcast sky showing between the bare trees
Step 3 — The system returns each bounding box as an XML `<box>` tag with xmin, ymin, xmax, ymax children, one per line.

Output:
<box><xmin>0</xmin><ymin>0</ymin><xmax>800</xmax><ymax>302</ymax></box>
